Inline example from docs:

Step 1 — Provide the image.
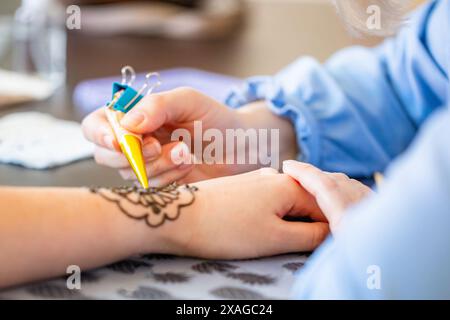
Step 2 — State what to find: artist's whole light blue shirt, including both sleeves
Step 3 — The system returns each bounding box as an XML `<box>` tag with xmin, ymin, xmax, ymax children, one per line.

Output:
<box><xmin>227</xmin><ymin>0</ymin><xmax>450</xmax><ymax>299</ymax></box>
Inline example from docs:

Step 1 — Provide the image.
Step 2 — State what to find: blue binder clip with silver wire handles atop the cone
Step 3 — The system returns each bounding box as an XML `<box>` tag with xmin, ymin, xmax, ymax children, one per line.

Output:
<box><xmin>110</xmin><ymin>66</ymin><xmax>161</xmax><ymax>113</ymax></box>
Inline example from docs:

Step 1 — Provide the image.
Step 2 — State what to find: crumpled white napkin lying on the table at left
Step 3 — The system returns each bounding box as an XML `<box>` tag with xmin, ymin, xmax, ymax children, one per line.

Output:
<box><xmin>0</xmin><ymin>112</ymin><xmax>94</xmax><ymax>169</ymax></box>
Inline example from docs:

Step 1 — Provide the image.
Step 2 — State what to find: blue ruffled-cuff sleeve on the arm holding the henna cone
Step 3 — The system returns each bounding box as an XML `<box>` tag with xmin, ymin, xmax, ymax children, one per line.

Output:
<box><xmin>226</xmin><ymin>1</ymin><xmax>450</xmax><ymax>177</ymax></box>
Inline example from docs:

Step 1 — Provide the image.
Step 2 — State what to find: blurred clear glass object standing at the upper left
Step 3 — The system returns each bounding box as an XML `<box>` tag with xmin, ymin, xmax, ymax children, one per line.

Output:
<box><xmin>11</xmin><ymin>0</ymin><xmax>66</xmax><ymax>89</ymax></box>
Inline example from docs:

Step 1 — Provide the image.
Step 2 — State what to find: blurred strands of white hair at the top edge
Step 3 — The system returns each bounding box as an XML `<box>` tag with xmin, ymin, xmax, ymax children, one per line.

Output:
<box><xmin>334</xmin><ymin>0</ymin><xmax>411</xmax><ymax>36</ymax></box>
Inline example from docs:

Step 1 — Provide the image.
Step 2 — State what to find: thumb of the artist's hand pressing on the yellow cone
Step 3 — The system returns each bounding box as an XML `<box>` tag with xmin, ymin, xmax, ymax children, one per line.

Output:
<box><xmin>121</xmin><ymin>88</ymin><xmax>218</xmax><ymax>133</ymax></box>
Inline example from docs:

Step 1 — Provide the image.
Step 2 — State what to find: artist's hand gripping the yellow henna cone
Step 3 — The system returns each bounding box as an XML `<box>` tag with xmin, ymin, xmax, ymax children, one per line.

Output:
<box><xmin>83</xmin><ymin>88</ymin><xmax>296</xmax><ymax>186</ymax></box>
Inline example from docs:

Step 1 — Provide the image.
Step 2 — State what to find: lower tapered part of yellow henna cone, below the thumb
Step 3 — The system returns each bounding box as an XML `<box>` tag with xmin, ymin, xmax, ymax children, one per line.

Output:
<box><xmin>119</xmin><ymin>134</ymin><xmax>149</xmax><ymax>189</ymax></box>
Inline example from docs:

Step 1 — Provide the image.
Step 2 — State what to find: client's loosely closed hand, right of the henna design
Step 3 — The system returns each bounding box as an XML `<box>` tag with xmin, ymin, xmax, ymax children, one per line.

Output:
<box><xmin>148</xmin><ymin>169</ymin><xmax>329</xmax><ymax>259</ymax></box>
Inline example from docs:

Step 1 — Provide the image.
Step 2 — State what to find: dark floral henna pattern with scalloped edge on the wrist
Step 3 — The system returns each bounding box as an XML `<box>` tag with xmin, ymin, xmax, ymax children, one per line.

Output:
<box><xmin>90</xmin><ymin>184</ymin><xmax>198</xmax><ymax>228</ymax></box>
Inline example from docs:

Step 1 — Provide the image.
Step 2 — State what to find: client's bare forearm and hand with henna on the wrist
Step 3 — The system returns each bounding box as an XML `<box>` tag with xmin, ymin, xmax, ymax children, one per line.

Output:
<box><xmin>0</xmin><ymin>169</ymin><xmax>328</xmax><ymax>288</ymax></box>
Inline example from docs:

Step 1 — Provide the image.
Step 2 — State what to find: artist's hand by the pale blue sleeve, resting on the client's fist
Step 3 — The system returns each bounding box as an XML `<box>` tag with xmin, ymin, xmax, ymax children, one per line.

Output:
<box><xmin>283</xmin><ymin>160</ymin><xmax>372</xmax><ymax>232</ymax></box>
